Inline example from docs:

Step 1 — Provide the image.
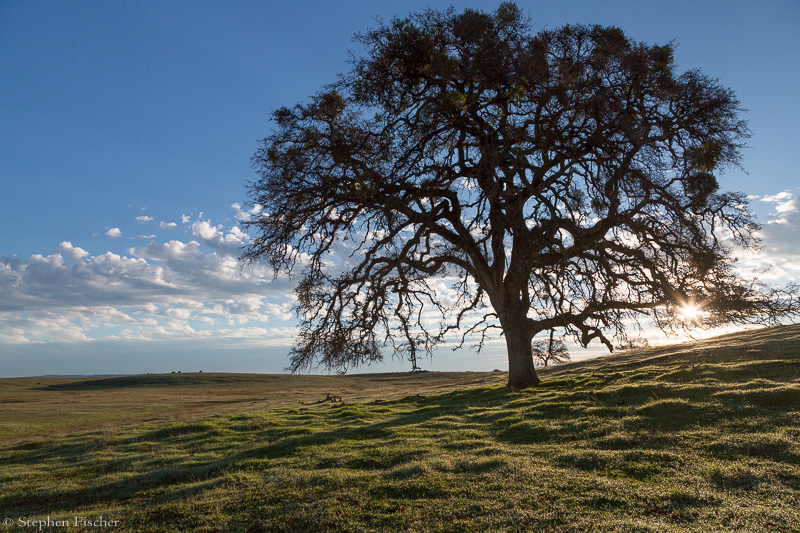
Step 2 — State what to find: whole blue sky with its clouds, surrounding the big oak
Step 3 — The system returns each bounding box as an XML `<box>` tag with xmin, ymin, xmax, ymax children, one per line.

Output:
<box><xmin>0</xmin><ymin>0</ymin><xmax>800</xmax><ymax>377</ymax></box>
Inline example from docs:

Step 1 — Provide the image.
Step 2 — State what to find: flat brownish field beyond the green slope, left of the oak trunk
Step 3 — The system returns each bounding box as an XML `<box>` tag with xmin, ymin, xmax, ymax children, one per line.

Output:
<box><xmin>0</xmin><ymin>372</ymin><xmax>508</xmax><ymax>442</ymax></box>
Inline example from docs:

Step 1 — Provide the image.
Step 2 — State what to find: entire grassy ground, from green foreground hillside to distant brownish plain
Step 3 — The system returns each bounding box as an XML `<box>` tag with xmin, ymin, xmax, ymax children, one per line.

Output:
<box><xmin>0</xmin><ymin>326</ymin><xmax>800</xmax><ymax>532</ymax></box>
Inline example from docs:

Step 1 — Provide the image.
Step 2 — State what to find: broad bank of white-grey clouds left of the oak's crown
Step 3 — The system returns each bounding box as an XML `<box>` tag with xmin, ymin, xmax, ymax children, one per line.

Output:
<box><xmin>0</xmin><ymin>214</ymin><xmax>293</xmax><ymax>344</ymax></box>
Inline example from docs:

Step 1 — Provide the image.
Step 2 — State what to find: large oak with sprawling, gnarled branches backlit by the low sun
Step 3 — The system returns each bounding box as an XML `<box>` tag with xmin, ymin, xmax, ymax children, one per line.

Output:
<box><xmin>243</xmin><ymin>3</ymin><xmax>797</xmax><ymax>387</ymax></box>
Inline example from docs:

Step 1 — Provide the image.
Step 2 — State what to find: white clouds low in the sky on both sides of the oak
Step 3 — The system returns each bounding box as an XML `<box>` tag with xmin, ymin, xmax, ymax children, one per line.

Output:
<box><xmin>0</xmin><ymin>191</ymin><xmax>800</xmax><ymax>373</ymax></box>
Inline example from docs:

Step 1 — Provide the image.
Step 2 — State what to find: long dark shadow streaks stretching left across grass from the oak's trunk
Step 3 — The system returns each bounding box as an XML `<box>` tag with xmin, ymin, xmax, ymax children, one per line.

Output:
<box><xmin>0</xmin><ymin>389</ymin><xmax>502</xmax><ymax>516</ymax></box>
